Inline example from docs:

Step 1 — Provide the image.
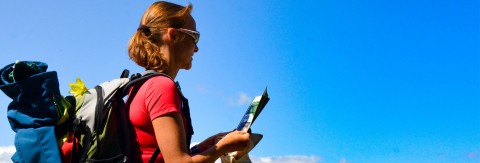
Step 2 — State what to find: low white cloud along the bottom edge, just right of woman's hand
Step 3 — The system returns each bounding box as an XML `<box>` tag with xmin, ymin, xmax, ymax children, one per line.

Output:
<box><xmin>250</xmin><ymin>155</ymin><xmax>323</xmax><ymax>163</ymax></box>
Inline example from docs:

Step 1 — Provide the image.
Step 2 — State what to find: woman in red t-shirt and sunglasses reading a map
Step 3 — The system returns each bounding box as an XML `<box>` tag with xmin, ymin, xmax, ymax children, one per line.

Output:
<box><xmin>128</xmin><ymin>2</ymin><xmax>250</xmax><ymax>163</ymax></box>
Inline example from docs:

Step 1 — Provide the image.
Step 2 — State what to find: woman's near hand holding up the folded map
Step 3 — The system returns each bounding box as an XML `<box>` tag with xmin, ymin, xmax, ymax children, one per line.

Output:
<box><xmin>217</xmin><ymin>131</ymin><xmax>250</xmax><ymax>152</ymax></box>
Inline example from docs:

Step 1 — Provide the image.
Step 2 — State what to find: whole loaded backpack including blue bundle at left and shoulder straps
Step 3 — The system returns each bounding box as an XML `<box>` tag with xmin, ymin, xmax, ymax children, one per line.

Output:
<box><xmin>0</xmin><ymin>61</ymin><xmax>193</xmax><ymax>162</ymax></box>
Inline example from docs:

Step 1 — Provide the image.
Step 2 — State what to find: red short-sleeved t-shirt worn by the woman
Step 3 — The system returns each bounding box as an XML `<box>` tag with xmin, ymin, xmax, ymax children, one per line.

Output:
<box><xmin>129</xmin><ymin>76</ymin><xmax>185</xmax><ymax>162</ymax></box>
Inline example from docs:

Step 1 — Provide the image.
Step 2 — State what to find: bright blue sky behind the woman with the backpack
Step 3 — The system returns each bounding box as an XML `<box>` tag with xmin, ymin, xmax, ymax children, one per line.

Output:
<box><xmin>0</xmin><ymin>0</ymin><xmax>480</xmax><ymax>163</ymax></box>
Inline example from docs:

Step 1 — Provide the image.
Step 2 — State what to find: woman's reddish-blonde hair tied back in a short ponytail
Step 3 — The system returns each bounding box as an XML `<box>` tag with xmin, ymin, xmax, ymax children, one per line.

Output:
<box><xmin>128</xmin><ymin>1</ymin><xmax>193</xmax><ymax>72</ymax></box>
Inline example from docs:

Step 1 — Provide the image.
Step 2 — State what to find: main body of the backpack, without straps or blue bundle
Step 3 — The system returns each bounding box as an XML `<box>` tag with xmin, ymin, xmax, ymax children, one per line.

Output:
<box><xmin>56</xmin><ymin>70</ymin><xmax>130</xmax><ymax>162</ymax></box>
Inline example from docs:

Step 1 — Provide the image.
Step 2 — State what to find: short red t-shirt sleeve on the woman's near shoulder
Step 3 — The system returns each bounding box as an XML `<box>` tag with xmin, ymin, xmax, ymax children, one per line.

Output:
<box><xmin>145</xmin><ymin>76</ymin><xmax>181</xmax><ymax>121</ymax></box>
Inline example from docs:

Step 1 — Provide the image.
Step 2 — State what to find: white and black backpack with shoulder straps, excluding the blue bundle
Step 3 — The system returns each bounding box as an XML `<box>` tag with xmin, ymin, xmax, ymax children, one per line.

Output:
<box><xmin>62</xmin><ymin>70</ymin><xmax>193</xmax><ymax>162</ymax></box>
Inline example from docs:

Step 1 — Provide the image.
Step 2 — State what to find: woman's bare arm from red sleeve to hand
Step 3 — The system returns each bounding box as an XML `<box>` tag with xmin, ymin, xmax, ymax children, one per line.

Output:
<box><xmin>152</xmin><ymin>113</ymin><xmax>250</xmax><ymax>163</ymax></box>
